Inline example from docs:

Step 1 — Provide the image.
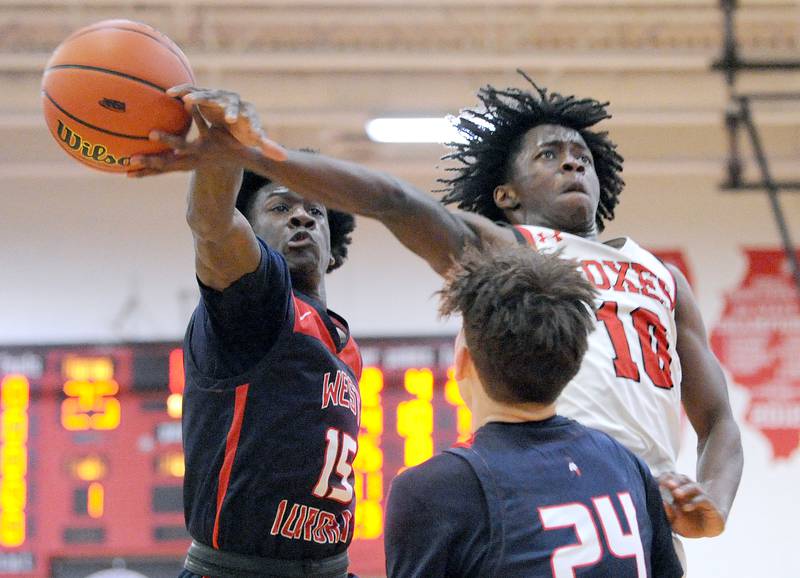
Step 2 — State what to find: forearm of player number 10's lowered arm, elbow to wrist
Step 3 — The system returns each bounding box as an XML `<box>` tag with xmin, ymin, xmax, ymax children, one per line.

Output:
<box><xmin>697</xmin><ymin>416</ymin><xmax>744</xmax><ymax>518</ymax></box>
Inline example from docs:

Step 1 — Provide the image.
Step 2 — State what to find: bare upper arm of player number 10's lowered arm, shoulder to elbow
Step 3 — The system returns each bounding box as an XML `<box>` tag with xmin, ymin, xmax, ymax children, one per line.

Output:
<box><xmin>671</xmin><ymin>269</ymin><xmax>731</xmax><ymax>437</ymax></box>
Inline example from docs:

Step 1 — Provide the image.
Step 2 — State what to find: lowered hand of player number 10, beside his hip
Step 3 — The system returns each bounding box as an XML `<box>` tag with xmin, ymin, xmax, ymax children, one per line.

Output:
<box><xmin>658</xmin><ymin>472</ymin><xmax>725</xmax><ymax>538</ymax></box>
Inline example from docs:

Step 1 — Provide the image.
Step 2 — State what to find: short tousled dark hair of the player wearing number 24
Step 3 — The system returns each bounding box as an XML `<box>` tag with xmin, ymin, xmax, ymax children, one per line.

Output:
<box><xmin>439</xmin><ymin>245</ymin><xmax>596</xmax><ymax>404</ymax></box>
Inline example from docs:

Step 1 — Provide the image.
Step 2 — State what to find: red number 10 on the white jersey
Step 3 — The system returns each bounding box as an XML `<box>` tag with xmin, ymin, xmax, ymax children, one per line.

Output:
<box><xmin>596</xmin><ymin>301</ymin><xmax>673</xmax><ymax>389</ymax></box>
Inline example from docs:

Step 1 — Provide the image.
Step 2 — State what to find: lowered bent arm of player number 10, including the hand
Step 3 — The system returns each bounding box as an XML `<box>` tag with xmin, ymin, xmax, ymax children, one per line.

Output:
<box><xmin>660</xmin><ymin>266</ymin><xmax>744</xmax><ymax>538</ymax></box>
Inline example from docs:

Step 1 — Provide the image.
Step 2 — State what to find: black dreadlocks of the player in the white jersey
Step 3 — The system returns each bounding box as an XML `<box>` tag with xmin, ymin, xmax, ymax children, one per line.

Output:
<box><xmin>439</xmin><ymin>70</ymin><xmax>625</xmax><ymax>231</ymax></box>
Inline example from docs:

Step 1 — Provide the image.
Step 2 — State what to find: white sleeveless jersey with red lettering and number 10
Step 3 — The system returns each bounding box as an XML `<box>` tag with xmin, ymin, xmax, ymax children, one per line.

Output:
<box><xmin>515</xmin><ymin>226</ymin><xmax>681</xmax><ymax>475</ymax></box>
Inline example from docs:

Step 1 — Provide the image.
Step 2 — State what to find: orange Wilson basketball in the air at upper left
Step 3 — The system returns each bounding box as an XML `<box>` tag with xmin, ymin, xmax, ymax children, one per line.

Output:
<box><xmin>42</xmin><ymin>20</ymin><xmax>194</xmax><ymax>172</ymax></box>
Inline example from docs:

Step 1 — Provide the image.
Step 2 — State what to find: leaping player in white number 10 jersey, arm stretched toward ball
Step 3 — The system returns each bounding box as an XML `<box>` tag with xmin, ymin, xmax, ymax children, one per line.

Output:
<box><xmin>132</xmin><ymin>72</ymin><xmax>743</xmax><ymax>537</ymax></box>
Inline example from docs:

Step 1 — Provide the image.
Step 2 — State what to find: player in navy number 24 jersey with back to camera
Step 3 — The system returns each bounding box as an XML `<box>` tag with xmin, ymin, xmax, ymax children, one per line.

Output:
<box><xmin>385</xmin><ymin>248</ymin><xmax>683</xmax><ymax>578</ymax></box>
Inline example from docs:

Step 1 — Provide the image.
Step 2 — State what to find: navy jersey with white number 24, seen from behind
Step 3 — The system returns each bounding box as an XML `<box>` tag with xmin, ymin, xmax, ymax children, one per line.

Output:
<box><xmin>386</xmin><ymin>416</ymin><xmax>683</xmax><ymax>578</ymax></box>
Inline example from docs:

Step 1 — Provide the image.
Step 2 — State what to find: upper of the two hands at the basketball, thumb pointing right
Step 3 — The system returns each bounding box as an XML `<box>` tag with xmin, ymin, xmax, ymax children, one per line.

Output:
<box><xmin>167</xmin><ymin>84</ymin><xmax>286</xmax><ymax>161</ymax></box>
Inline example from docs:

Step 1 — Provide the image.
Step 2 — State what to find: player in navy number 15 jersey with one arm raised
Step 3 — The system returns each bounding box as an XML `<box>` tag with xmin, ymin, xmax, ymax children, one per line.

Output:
<box><xmin>136</xmin><ymin>114</ymin><xmax>361</xmax><ymax>578</ymax></box>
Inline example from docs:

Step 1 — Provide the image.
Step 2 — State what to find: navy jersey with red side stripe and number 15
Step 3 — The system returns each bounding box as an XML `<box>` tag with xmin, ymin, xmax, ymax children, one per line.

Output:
<box><xmin>183</xmin><ymin>237</ymin><xmax>361</xmax><ymax>560</ymax></box>
